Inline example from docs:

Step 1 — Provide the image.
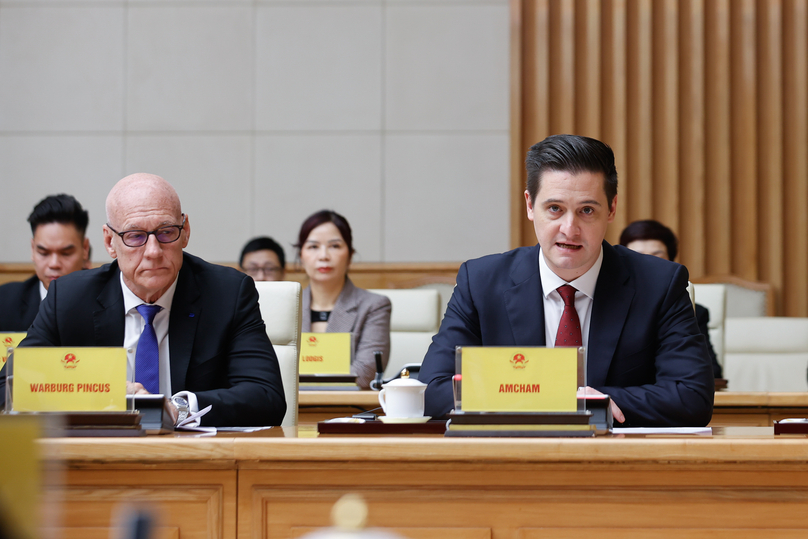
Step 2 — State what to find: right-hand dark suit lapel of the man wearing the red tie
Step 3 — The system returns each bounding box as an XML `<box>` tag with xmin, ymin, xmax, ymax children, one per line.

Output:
<box><xmin>586</xmin><ymin>241</ymin><xmax>635</xmax><ymax>385</ymax></box>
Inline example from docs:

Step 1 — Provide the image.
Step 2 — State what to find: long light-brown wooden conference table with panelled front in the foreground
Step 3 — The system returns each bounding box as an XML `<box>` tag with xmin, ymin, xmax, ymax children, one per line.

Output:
<box><xmin>41</xmin><ymin>425</ymin><xmax>808</xmax><ymax>539</ymax></box>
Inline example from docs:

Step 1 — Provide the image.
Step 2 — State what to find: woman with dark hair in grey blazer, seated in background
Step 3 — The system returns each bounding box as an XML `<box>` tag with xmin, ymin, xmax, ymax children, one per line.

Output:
<box><xmin>295</xmin><ymin>210</ymin><xmax>392</xmax><ymax>388</ymax></box>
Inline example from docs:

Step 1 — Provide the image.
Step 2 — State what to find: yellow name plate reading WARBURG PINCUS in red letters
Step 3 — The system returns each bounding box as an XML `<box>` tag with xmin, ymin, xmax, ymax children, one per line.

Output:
<box><xmin>12</xmin><ymin>347</ymin><xmax>126</xmax><ymax>412</ymax></box>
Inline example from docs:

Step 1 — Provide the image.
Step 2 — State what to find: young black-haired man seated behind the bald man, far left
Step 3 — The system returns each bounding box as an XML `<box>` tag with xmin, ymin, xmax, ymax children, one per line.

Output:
<box><xmin>0</xmin><ymin>194</ymin><xmax>90</xmax><ymax>332</ymax></box>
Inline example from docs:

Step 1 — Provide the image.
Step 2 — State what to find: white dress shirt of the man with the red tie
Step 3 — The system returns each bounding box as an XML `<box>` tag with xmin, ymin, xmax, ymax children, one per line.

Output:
<box><xmin>539</xmin><ymin>247</ymin><xmax>603</xmax><ymax>350</ymax></box>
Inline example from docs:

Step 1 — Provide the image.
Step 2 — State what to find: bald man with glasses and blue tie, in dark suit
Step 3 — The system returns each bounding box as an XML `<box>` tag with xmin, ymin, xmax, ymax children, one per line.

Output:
<box><xmin>0</xmin><ymin>174</ymin><xmax>286</xmax><ymax>426</ymax></box>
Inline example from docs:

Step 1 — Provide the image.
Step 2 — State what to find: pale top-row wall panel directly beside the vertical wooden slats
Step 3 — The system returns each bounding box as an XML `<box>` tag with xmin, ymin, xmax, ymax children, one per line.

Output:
<box><xmin>385</xmin><ymin>2</ymin><xmax>509</xmax><ymax>130</ymax></box>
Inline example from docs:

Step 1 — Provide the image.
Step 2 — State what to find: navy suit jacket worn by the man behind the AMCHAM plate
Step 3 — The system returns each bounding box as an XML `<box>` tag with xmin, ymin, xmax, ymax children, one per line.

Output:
<box><xmin>420</xmin><ymin>242</ymin><xmax>714</xmax><ymax>426</ymax></box>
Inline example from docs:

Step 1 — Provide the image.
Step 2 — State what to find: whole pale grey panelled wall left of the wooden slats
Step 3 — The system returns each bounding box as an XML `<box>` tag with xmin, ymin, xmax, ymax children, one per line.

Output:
<box><xmin>0</xmin><ymin>0</ymin><xmax>510</xmax><ymax>262</ymax></box>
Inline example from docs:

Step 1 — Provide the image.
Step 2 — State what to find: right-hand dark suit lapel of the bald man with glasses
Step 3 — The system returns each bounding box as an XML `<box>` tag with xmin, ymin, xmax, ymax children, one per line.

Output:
<box><xmin>168</xmin><ymin>255</ymin><xmax>202</xmax><ymax>393</ymax></box>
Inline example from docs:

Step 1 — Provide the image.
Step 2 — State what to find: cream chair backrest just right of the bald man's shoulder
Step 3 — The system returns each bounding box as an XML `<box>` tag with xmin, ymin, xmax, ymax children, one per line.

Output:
<box><xmin>255</xmin><ymin>281</ymin><xmax>301</xmax><ymax>427</ymax></box>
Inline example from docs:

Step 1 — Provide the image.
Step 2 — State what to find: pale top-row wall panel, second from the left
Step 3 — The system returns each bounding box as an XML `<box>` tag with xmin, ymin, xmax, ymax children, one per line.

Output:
<box><xmin>126</xmin><ymin>3</ymin><xmax>253</xmax><ymax>131</ymax></box>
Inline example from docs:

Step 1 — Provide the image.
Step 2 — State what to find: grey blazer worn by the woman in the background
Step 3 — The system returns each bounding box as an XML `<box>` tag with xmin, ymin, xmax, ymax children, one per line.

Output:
<box><xmin>301</xmin><ymin>279</ymin><xmax>392</xmax><ymax>389</ymax></box>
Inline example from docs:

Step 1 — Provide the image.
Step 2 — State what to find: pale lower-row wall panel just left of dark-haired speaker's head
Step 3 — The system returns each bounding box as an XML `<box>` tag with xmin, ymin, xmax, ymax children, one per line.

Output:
<box><xmin>384</xmin><ymin>134</ymin><xmax>510</xmax><ymax>262</ymax></box>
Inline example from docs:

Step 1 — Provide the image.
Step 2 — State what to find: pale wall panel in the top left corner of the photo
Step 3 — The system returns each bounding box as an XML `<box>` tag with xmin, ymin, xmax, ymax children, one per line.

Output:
<box><xmin>0</xmin><ymin>4</ymin><xmax>124</xmax><ymax>131</ymax></box>
